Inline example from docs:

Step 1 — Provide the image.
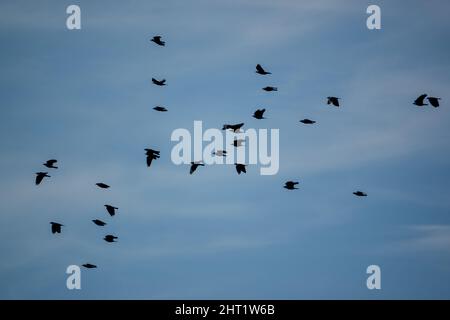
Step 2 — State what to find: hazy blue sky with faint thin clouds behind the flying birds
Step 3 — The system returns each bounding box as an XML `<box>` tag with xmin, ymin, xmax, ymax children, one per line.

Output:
<box><xmin>0</xmin><ymin>0</ymin><xmax>450</xmax><ymax>299</ymax></box>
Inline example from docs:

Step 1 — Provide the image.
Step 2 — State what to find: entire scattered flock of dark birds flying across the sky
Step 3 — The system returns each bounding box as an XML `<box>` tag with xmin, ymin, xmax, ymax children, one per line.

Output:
<box><xmin>35</xmin><ymin>36</ymin><xmax>440</xmax><ymax>269</ymax></box>
